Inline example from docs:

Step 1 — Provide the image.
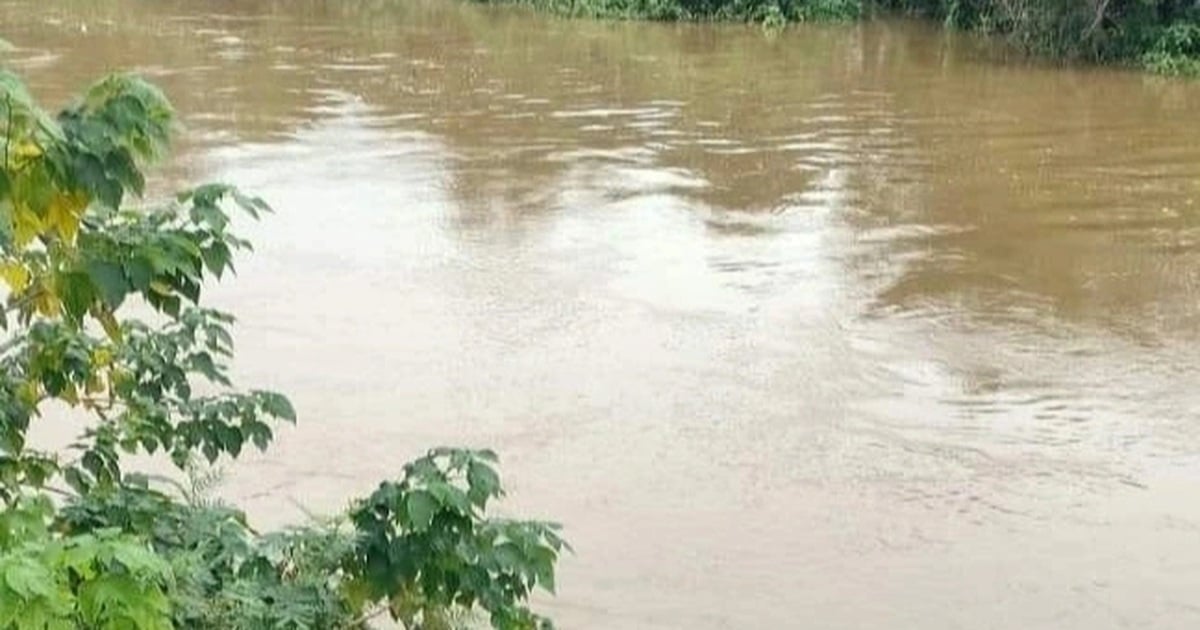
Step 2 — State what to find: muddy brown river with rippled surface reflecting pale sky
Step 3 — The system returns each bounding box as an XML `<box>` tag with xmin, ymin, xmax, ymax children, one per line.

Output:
<box><xmin>7</xmin><ymin>0</ymin><xmax>1200</xmax><ymax>630</ymax></box>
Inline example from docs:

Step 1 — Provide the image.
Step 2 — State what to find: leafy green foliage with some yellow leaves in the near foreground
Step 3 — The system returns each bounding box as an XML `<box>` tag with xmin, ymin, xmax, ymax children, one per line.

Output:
<box><xmin>0</xmin><ymin>72</ymin><xmax>565</xmax><ymax>630</ymax></box>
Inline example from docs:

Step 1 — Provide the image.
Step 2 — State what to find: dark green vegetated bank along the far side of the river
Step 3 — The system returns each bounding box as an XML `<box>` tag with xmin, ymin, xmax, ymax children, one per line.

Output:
<box><xmin>465</xmin><ymin>0</ymin><xmax>1200</xmax><ymax>76</ymax></box>
